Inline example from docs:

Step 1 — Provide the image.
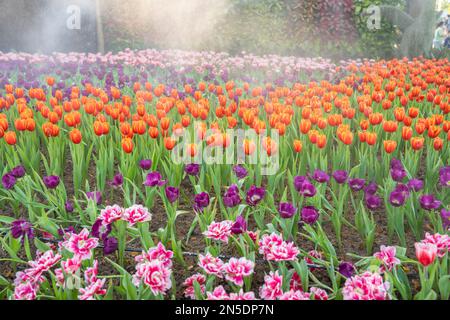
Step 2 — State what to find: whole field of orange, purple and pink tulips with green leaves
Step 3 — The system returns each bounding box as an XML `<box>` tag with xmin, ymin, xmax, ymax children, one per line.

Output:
<box><xmin>0</xmin><ymin>50</ymin><xmax>450</xmax><ymax>300</ymax></box>
